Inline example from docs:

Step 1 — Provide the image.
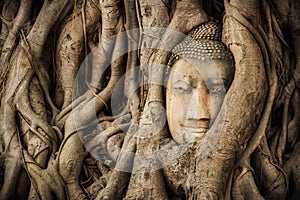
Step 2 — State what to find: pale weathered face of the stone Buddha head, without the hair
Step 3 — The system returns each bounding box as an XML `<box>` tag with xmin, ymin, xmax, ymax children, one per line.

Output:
<box><xmin>166</xmin><ymin>59</ymin><xmax>233</xmax><ymax>143</ymax></box>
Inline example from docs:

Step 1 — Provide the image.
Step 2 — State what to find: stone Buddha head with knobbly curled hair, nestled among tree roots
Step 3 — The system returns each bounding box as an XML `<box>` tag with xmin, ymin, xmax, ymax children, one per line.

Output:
<box><xmin>166</xmin><ymin>21</ymin><xmax>234</xmax><ymax>144</ymax></box>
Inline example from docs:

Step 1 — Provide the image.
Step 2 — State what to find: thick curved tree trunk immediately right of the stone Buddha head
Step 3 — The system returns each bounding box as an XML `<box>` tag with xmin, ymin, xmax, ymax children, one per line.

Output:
<box><xmin>189</xmin><ymin>0</ymin><xmax>272</xmax><ymax>199</ymax></box>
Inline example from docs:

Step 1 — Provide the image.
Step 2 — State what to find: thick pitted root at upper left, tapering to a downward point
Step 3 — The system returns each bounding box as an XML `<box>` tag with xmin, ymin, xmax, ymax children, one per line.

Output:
<box><xmin>56</xmin><ymin>1</ymin><xmax>100</xmax><ymax>109</ymax></box>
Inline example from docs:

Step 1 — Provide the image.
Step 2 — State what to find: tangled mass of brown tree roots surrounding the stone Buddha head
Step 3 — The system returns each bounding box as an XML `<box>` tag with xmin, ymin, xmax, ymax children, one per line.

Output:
<box><xmin>0</xmin><ymin>0</ymin><xmax>300</xmax><ymax>200</ymax></box>
